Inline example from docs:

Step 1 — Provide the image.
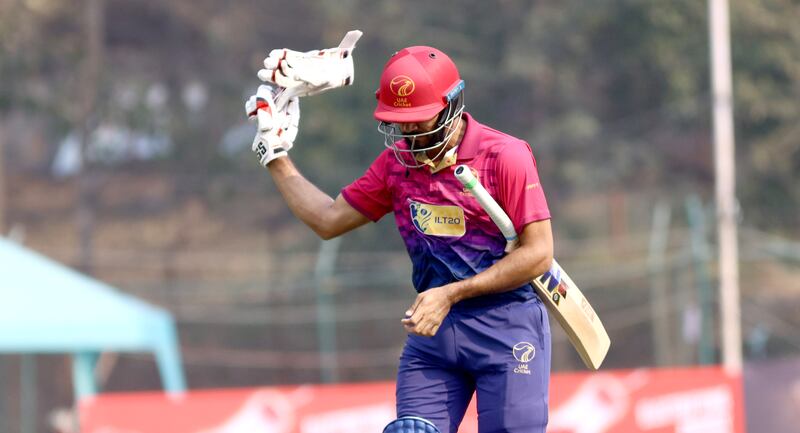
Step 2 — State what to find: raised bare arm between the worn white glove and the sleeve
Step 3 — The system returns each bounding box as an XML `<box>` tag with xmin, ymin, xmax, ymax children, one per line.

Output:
<box><xmin>267</xmin><ymin>157</ymin><xmax>369</xmax><ymax>239</ymax></box>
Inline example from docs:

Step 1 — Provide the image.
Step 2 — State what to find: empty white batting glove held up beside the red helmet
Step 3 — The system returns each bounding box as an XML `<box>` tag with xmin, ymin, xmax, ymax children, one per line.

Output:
<box><xmin>258</xmin><ymin>30</ymin><xmax>362</xmax><ymax>108</ymax></box>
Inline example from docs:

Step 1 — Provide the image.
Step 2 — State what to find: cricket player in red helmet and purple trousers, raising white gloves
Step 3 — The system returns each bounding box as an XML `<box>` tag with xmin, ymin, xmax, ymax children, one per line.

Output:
<box><xmin>246</xmin><ymin>36</ymin><xmax>553</xmax><ymax>433</ymax></box>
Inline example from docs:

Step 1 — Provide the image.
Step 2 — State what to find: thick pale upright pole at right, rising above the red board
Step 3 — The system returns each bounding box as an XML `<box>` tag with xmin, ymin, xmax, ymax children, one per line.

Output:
<box><xmin>708</xmin><ymin>0</ymin><xmax>742</xmax><ymax>375</ymax></box>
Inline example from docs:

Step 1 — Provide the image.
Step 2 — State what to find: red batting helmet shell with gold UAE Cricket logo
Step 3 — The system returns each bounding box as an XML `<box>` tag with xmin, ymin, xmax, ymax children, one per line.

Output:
<box><xmin>375</xmin><ymin>46</ymin><xmax>464</xmax><ymax>123</ymax></box>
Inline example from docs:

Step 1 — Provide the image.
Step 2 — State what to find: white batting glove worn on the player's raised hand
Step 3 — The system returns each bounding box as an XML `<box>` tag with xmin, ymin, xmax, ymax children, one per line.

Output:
<box><xmin>244</xmin><ymin>84</ymin><xmax>300</xmax><ymax>167</ymax></box>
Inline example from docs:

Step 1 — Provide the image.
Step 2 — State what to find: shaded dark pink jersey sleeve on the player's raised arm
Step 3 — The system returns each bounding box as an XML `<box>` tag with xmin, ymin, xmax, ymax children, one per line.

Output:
<box><xmin>342</xmin><ymin>152</ymin><xmax>392</xmax><ymax>222</ymax></box>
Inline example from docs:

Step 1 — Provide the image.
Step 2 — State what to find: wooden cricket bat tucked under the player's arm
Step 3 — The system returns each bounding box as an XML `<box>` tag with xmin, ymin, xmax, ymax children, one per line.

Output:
<box><xmin>455</xmin><ymin>165</ymin><xmax>611</xmax><ymax>370</ymax></box>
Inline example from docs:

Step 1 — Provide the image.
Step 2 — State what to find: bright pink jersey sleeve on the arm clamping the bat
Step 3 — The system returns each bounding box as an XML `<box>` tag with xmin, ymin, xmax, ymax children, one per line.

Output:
<box><xmin>496</xmin><ymin>141</ymin><xmax>550</xmax><ymax>233</ymax></box>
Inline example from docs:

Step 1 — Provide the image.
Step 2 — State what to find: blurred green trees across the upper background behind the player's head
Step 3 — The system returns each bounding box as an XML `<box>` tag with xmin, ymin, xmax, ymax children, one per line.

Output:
<box><xmin>0</xmin><ymin>0</ymin><xmax>800</xmax><ymax>231</ymax></box>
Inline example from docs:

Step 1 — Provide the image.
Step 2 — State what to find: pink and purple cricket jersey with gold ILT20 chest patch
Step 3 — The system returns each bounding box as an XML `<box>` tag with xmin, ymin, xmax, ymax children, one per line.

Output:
<box><xmin>342</xmin><ymin>114</ymin><xmax>550</xmax><ymax>304</ymax></box>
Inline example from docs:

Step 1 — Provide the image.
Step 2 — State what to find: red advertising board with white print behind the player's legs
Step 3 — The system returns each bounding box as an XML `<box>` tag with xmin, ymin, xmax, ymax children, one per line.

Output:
<box><xmin>80</xmin><ymin>368</ymin><xmax>744</xmax><ymax>433</ymax></box>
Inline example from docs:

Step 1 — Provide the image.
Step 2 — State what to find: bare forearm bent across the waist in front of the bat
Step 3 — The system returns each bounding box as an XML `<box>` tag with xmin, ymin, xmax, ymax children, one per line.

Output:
<box><xmin>443</xmin><ymin>220</ymin><xmax>553</xmax><ymax>303</ymax></box>
